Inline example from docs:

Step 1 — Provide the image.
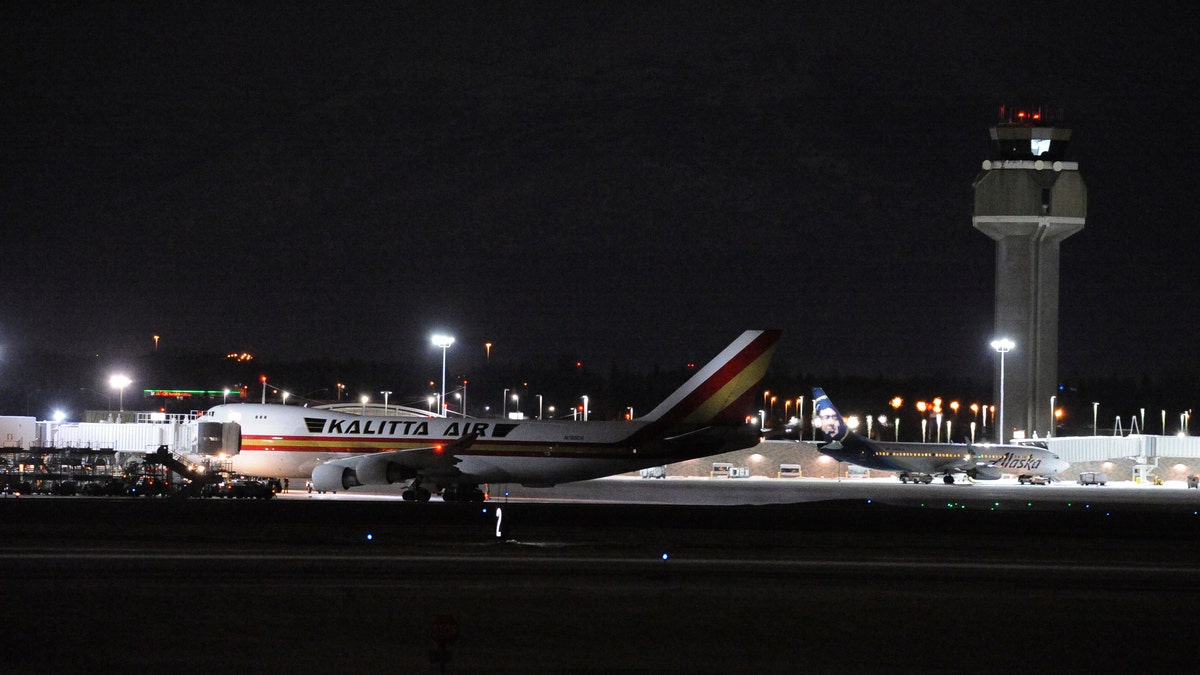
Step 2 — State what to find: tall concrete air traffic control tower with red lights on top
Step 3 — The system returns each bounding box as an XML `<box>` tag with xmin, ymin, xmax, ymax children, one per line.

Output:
<box><xmin>972</xmin><ymin>108</ymin><xmax>1087</xmax><ymax>441</ymax></box>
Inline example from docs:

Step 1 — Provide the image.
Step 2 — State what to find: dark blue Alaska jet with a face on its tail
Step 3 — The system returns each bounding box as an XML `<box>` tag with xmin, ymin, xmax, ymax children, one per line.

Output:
<box><xmin>812</xmin><ymin>387</ymin><xmax>1069</xmax><ymax>483</ymax></box>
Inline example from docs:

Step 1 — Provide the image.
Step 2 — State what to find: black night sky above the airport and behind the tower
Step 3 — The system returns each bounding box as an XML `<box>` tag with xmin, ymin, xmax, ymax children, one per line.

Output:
<box><xmin>0</xmin><ymin>2</ymin><xmax>1200</xmax><ymax>378</ymax></box>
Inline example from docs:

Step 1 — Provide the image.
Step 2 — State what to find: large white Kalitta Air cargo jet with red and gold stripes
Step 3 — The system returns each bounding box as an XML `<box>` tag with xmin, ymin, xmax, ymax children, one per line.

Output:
<box><xmin>197</xmin><ymin>330</ymin><xmax>780</xmax><ymax>501</ymax></box>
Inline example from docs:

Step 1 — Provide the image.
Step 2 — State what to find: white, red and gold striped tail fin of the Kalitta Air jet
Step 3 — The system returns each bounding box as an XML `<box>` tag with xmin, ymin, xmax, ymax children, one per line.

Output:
<box><xmin>641</xmin><ymin>330</ymin><xmax>780</xmax><ymax>424</ymax></box>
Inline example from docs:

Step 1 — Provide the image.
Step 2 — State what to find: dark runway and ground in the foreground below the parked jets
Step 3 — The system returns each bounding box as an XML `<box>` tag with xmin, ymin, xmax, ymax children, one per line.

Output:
<box><xmin>0</xmin><ymin>479</ymin><xmax>1200</xmax><ymax>673</ymax></box>
